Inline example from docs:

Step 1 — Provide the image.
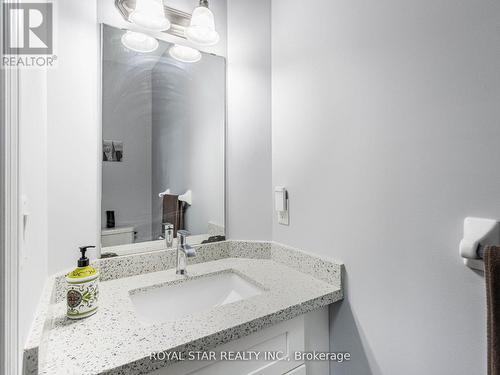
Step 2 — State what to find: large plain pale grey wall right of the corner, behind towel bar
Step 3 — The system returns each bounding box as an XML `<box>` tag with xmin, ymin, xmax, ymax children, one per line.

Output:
<box><xmin>272</xmin><ymin>0</ymin><xmax>500</xmax><ymax>375</ymax></box>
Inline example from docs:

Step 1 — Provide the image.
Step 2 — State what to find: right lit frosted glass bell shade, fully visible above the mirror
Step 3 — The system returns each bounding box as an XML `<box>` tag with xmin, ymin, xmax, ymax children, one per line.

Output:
<box><xmin>186</xmin><ymin>6</ymin><xmax>220</xmax><ymax>46</ymax></box>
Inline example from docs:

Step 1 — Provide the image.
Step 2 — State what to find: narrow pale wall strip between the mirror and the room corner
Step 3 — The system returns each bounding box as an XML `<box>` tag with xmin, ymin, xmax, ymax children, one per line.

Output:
<box><xmin>226</xmin><ymin>0</ymin><xmax>273</xmax><ymax>240</ymax></box>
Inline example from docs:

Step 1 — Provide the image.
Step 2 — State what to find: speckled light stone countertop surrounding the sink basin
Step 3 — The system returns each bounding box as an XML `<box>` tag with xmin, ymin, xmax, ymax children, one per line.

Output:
<box><xmin>29</xmin><ymin>243</ymin><xmax>342</xmax><ymax>375</ymax></box>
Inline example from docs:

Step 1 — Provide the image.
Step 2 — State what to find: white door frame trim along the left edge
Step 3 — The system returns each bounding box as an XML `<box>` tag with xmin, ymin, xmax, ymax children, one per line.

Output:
<box><xmin>0</xmin><ymin>0</ymin><xmax>21</xmax><ymax>375</ymax></box>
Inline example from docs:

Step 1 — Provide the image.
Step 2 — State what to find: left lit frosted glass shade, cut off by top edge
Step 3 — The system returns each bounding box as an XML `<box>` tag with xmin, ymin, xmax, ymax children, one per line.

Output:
<box><xmin>129</xmin><ymin>0</ymin><xmax>171</xmax><ymax>31</ymax></box>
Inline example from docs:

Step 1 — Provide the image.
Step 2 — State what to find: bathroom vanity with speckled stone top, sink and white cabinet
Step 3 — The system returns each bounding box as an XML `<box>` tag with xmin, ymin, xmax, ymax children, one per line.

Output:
<box><xmin>24</xmin><ymin>241</ymin><xmax>343</xmax><ymax>375</ymax></box>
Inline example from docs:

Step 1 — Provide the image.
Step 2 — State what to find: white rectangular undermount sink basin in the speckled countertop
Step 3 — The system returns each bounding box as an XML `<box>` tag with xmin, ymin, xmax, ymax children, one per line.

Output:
<box><xmin>130</xmin><ymin>272</ymin><xmax>264</xmax><ymax>323</ymax></box>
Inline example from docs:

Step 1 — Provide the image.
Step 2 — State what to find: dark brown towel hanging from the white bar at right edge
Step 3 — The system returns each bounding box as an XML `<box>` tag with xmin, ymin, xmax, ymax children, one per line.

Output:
<box><xmin>484</xmin><ymin>246</ymin><xmax>500</xmax><ymax>375</ymax></box>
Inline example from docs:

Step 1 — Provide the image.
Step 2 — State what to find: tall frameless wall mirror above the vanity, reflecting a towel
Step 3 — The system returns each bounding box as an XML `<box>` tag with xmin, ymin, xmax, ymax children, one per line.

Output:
<box><xmin>101</xmin><ymin>25</ymin><xmax>226</xmax><ymax>257</ymax></box>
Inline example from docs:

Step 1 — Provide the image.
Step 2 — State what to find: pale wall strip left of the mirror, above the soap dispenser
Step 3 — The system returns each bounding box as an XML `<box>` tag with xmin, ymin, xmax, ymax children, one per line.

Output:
<box><xmin>47</xmin><ymin>0</ymin><xmax>100</xmax><ymax>273</ymax></box>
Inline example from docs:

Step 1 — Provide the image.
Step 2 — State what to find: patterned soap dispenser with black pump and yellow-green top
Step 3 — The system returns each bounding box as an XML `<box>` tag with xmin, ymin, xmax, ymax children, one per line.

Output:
<box><xmin>66</xmin><ymin>246</ymin><xmax>99</xmax><ymax>319</ymax></box>
